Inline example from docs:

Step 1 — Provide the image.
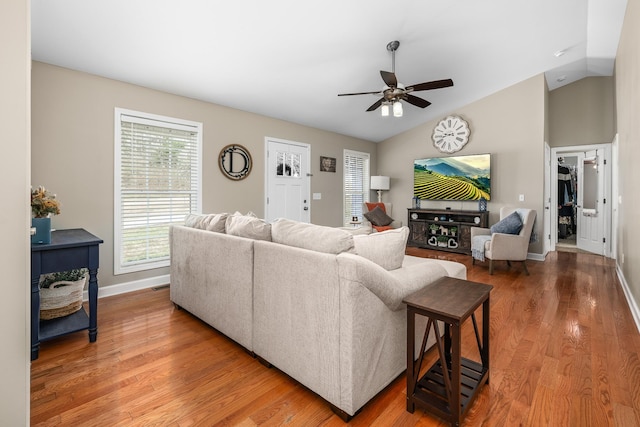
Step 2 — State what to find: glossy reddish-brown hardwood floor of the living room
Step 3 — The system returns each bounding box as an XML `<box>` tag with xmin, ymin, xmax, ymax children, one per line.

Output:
<box><xmin>31</xmin><ymin>248</ymin><xmax>640</xmax><ymax>426</ymax></box>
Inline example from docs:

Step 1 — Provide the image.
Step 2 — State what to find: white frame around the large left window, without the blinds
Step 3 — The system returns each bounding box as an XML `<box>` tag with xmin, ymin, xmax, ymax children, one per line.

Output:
<box><xmin>113</xmin><ymin>107</ymin><xmax>203</xmax><ymax>275</ymax></box>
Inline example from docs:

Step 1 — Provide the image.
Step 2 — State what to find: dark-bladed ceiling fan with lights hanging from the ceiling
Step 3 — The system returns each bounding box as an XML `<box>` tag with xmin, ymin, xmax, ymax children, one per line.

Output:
<box><xmin>338</xmin><ymin>40</ymin><xmax>453</xmax><ymax>117</ymax></box>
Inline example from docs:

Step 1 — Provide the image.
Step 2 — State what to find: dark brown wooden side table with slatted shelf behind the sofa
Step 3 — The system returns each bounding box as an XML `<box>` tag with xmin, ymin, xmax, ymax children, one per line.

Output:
<box><xmin>404</xmin><ymin>277</ymin><xmax>493</xmax><ymax>426</ymax></box>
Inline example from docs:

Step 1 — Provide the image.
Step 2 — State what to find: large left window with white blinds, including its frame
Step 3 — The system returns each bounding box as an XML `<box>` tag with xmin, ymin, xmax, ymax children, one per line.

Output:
<box><xmin>114</xmin><ymin>108</ymin><xmax>202</xmax><ymax>274</ymax></box>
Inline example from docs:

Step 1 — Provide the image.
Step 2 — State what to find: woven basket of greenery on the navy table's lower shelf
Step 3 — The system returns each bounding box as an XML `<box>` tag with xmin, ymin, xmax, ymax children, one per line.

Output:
<box><xmin>39</xmin><ymin>268</ymin><xmax>88</xmax><ymax>320</ymax></box>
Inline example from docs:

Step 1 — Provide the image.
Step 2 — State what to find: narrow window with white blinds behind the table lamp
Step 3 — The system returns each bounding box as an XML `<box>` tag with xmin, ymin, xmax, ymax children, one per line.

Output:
<box><xmin>343</xmin><ymin>150</ymin><xmax>370</xmax><ymax>225</ymax></box>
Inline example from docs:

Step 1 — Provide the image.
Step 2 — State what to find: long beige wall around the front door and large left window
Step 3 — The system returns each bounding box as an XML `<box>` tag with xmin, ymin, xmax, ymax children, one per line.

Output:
<box><xmin>31</xmin><ymin>62</ymin><xmax>376</xmax><ymax>286</ymax></box>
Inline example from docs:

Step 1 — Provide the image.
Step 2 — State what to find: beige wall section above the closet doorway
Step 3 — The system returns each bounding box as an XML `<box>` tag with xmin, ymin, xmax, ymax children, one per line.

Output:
<box><xmin>549</xmin><ymin>77</ymin><xmax>615</xmax><ymax>147</ymax></box>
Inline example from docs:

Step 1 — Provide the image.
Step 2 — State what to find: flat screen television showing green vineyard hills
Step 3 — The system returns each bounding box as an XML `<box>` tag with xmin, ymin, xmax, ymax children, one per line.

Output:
<box><xmin>413</xmin><ymin>154</ymin><xmax>491</xmax><ymax>200</ymax></box>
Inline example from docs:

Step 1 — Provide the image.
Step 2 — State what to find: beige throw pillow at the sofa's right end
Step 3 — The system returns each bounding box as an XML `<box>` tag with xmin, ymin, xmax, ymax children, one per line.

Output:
<box><xmin>353</xmin><ymin>227</ymin><xmax>409</xmax><ymax>270</ymax></box>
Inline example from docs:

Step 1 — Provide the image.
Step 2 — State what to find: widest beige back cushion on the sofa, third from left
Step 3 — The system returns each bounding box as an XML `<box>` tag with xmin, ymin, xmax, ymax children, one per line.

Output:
<box><xmin>271</xmin><ymin>218</ymin><xmax>354</xmax><ymax>254</ymax></box>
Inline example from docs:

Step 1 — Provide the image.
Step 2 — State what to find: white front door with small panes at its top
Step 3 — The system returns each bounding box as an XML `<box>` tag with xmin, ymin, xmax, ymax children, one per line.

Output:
<box><xmin>265</xmin><ymin>138</ymin><xmax>311</xmax><ymax>222</ymax></box>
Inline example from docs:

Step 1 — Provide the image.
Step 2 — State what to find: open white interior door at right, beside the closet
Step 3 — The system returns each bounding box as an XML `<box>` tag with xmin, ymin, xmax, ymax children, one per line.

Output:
<box><xmin>576</xmin><ymin>149</ymin><xmax>606</xmax><ymax>255</ymax></box>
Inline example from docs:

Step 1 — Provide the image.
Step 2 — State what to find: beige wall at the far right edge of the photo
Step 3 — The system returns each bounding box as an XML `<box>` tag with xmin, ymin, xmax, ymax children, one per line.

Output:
<box><xmin>616</xmin><ymin>0</ymin><xmax>640</xmax><ymax>304</ymax></box>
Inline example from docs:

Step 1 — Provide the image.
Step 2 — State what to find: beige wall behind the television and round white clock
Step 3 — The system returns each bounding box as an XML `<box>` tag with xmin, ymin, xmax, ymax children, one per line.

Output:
<box><xmin>378</xmin><ymin>75</ymin><xmax>547</xmax><ymax>254</ymax></box>
